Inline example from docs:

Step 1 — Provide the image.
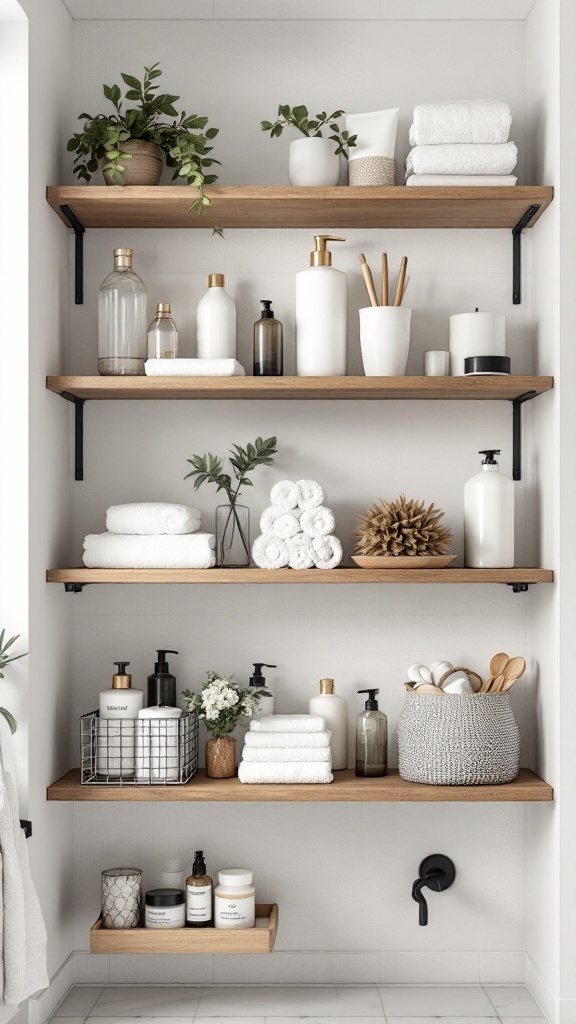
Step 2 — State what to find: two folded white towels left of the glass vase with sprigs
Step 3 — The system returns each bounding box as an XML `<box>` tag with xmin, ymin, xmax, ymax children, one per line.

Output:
<box><xmin>82</xmin><ymin>502</ymin><xmax>215</xmax><ymax>569</ymax></box>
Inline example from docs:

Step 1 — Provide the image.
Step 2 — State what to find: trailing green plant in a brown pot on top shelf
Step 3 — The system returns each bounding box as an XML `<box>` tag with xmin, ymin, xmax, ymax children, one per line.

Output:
<box><xmin>68</xmin><ymin>63</ymin><xmax>219</xmax><ymax>227</ymax></box>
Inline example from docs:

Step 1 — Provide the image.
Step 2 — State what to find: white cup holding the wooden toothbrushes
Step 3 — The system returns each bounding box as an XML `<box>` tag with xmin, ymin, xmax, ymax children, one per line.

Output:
<box><xmin>359</xmin><ymin>306</ymin><xmax>412</xmax><ymax>377</ymax></box>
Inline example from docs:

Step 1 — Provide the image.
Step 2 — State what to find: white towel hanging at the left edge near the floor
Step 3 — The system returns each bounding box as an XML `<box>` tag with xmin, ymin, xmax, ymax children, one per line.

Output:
<box><xmin>0</xmin><ymin>765</ymin><xmax>49</xmax><ymax>1024</ymax></box>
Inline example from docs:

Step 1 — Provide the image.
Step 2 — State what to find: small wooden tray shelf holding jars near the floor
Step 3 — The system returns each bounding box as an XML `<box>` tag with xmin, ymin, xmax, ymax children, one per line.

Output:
<box><xmin>90</xmin><ymin>903</ymin><xmax>278</xmax><ymax>953</ymax></box>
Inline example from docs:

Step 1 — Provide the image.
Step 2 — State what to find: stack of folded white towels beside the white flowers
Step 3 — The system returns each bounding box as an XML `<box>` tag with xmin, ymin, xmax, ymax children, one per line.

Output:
<box><xmin>238</xmin><ymin>715</ymin><xmax>334</xmax><ymax>783</ymax></box>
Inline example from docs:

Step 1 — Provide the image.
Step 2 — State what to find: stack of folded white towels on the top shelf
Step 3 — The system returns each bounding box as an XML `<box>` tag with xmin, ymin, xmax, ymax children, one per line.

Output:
<box><xmin>406</xmin><ymin>99</ymin><xmax>518</xmax><ymax>185</ymax></box>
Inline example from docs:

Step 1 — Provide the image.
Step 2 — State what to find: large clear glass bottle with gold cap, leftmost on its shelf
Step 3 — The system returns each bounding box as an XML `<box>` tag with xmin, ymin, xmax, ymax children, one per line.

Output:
<box><xmin>98</xmin><ymin>249</ymin><xmax>148</xmax><ymax>376</ymax></box>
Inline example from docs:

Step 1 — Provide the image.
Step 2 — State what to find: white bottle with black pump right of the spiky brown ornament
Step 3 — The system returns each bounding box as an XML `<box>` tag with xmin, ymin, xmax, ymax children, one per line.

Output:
<box><xmin>464</xmin><ymin>449</ymin><xmax>515</xmax><ymax>569</ymax></box>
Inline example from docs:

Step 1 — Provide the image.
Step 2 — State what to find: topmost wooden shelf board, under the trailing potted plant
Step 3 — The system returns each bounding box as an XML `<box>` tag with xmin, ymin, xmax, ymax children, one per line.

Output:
<box><xmin>46</xmin><ymin>185</ymin><xmax>553</xmax><ymax>228</ymax></box>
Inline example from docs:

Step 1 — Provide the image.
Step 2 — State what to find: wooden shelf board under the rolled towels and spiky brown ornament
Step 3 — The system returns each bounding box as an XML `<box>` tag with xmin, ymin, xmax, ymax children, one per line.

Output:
<box><xmin>46</xmin><ymin>568</ymin><xmax>553</xmax><ymax>585</ymax></box>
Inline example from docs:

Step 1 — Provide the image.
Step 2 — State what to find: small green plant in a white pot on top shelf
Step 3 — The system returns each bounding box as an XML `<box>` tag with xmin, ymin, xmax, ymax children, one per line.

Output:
<box><xmin>261</xmin><ymin>103</ymin><xmax>357</xmax><ymax>186</ymax></box>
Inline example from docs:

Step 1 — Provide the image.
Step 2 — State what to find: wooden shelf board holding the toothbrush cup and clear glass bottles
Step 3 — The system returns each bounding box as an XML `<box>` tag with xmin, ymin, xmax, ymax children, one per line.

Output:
<box><xmin>46</xmin><ymin>376</ymin><xmax>553</xmax><ymax>401</ymax></box>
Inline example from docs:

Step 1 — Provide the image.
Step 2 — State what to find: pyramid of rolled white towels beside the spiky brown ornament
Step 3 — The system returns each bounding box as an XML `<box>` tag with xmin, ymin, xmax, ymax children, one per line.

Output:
<box><xmin>252</xmin><ymin>480</ymin><xmax>342</xmax><ymax>569</ymax></box>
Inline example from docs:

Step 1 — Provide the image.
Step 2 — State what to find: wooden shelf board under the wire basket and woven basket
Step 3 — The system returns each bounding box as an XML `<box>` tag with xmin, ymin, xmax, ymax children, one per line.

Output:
<box><xmin>47</xmin><ymin>770</ymin><xmax>553</xmax><ymax>803</ymax></box>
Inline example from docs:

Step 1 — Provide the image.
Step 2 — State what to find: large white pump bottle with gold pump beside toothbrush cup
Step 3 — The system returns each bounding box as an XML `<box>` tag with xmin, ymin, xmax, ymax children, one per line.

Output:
<box><xmin>296</xmin><ymin>234</ymin><xmax>347</xmax><ymax>377</ymax></box>
